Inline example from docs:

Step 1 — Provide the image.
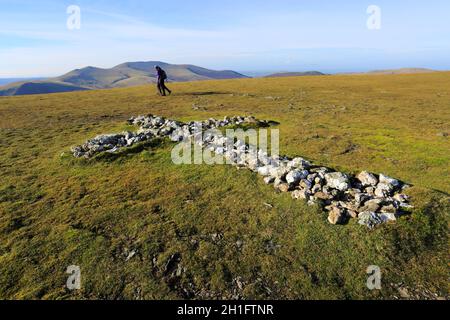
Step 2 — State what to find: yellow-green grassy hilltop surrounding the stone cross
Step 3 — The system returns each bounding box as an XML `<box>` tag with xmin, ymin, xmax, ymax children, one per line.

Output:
<box><xmin>0</xmin><ymin>73</ymin><xmax>450</xmax><ymax>299</ymax></box>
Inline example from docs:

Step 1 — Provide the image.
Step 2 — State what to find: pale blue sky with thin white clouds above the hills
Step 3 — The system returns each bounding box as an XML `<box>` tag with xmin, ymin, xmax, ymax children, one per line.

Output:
<box><xmin>0</xmin><ymin>0</ymin><xmax>450</xmax><ymax>77</ymax></box>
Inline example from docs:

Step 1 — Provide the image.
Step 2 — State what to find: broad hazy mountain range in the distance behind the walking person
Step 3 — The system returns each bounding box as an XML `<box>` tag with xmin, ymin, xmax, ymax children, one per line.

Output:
<box><xmin>0</xmin><ymin>61</ymin><xmax>248</xmax><ymax>96</ymax></box>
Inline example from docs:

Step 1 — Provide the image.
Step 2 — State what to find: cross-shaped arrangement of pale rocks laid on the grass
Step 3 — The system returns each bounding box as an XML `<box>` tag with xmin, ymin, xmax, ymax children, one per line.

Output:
<box><xmin>72</xmin><ymin>115</ymin><xmax>412</xmax><ymax>228</ymax></box>
